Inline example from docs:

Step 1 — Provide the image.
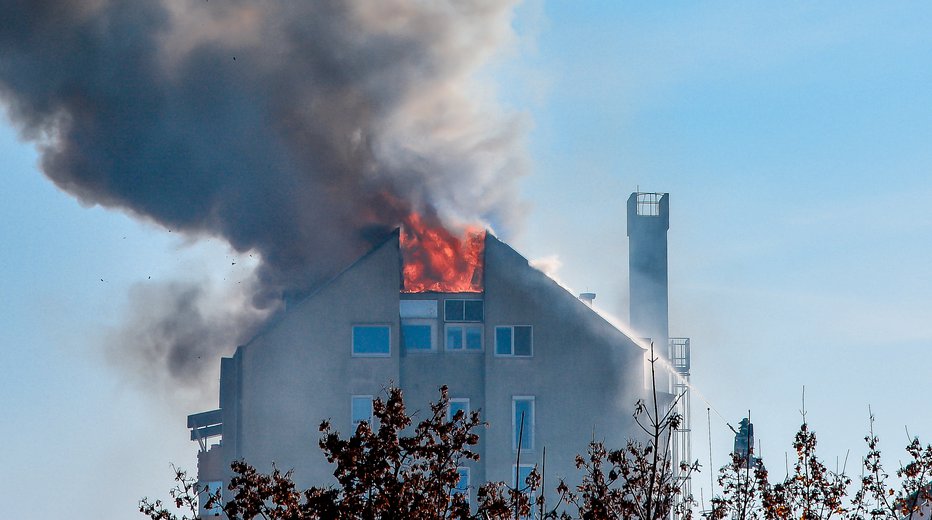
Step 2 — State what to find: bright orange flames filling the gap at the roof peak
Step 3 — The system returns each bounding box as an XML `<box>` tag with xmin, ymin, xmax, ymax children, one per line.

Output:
<box><xmin>401</xmin><ymin>213</ymin><xmax>485</xmax><ymax>293</ymax></box>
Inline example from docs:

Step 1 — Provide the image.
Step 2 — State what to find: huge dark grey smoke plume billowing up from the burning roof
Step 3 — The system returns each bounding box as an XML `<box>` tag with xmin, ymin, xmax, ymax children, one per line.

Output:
<box><xmin>0</xmin><ymin>0</ymin><xmax>526</xmax><ymax>390</ymax></box>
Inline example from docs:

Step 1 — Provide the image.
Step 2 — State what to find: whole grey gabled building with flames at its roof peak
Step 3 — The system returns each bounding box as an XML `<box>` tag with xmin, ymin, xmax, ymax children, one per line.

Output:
<box><xmin>188</xmin><ymin>191</ymin><xmax>688</xmax><ymax>512</ymax></box>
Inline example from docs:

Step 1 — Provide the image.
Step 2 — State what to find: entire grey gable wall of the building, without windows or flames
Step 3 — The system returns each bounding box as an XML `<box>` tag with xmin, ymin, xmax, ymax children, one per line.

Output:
<box><xmin>216</xmin><ymin>234</ymin><xmax>644</xmax><ymax>496</ymax></box>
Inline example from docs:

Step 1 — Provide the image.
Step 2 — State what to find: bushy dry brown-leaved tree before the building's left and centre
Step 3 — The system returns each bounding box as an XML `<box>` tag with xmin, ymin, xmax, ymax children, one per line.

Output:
<box><xmin>140</xmin><ymin>386</ymin><xmax>536</xmax><ymax>520</ymax></box>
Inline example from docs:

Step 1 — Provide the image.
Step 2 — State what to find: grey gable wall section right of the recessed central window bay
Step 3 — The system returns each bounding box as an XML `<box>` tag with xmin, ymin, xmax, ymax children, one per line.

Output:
<box><xmin>485</xmin><ymin>237</ymin><xmax>644</xmax><ymax>482</ymax></box>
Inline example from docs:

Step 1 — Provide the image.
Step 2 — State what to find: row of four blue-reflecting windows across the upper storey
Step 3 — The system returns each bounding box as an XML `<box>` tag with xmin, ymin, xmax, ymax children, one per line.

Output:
<box><xmin>353</xmin><ymin>324</ymin><xmax>534</xmax><ymax>357</ymax></box>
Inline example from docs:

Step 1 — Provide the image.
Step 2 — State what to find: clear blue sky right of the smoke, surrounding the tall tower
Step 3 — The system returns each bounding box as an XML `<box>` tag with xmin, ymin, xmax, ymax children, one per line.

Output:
<box><xmin>518</xmin><ymin>3</ymin><xmax>932</xmax><ymax>504</ymax></box>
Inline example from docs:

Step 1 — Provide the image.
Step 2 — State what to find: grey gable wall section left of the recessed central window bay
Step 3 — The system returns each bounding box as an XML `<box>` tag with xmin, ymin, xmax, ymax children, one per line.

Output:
<box><xmin>239</xmin><ymin>233</ymin><xmax>401</xmax><ymax>485</ymax></box>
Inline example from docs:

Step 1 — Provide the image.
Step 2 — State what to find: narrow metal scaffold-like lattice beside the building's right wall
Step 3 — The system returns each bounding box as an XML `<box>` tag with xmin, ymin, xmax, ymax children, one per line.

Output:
<box><xmin>669</xmin><ymin>338</ymin><xmax>692</xmax><ymax>516</ymax></box>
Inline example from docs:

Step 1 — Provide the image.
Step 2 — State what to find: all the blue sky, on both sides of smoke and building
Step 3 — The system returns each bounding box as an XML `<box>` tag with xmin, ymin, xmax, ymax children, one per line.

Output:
<box><xmin>0</xmin><ymin>2</ymin><xmax>932</xmax><ymax>518</ymax></box>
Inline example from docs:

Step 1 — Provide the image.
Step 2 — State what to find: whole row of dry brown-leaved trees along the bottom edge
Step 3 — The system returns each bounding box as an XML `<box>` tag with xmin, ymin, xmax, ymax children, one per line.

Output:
<box><xmin>140</xmin><ymin>348</ymin><xmax>932</xmax><ymax>520</ymax></box>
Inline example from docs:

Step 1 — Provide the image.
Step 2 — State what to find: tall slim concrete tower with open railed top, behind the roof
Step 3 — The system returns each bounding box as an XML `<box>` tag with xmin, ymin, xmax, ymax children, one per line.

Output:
<box><xmin>628</xmin><ymin>192</ymin><xmax>670</xmax><ymax>346</ymax></box>
